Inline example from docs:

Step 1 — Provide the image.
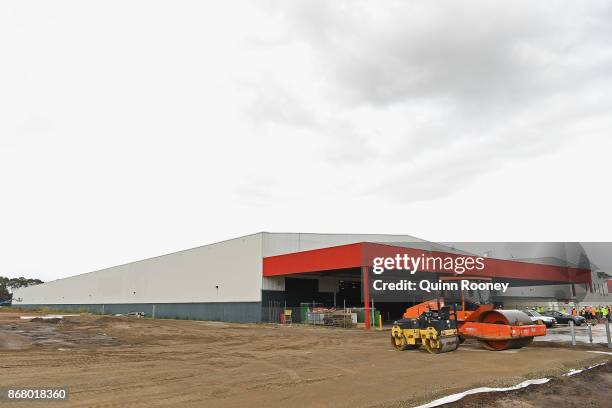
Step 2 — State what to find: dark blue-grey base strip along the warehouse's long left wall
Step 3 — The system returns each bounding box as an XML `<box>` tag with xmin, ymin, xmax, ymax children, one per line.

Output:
<box><xmin>13</xmin><ymin>302</ymin><xmax>261</xmax><ymax>323</ymax></box>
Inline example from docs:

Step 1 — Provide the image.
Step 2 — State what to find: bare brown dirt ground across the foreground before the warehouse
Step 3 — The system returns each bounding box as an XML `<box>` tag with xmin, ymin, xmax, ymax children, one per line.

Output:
<box><xmin>0</xmin><ymin>311</ymin><xmax>611</xmax><ymax>408</ymax></box>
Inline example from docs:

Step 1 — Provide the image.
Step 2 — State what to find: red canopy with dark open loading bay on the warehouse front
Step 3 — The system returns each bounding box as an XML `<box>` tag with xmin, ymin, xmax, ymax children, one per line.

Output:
<box><xmin>262</xmin><ymin>242</ymin><xmax>590</xmax><ymax>329</ymax></box>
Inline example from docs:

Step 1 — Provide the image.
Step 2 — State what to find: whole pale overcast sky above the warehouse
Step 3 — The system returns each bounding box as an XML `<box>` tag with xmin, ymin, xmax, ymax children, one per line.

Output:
<box><xmin>0</xmin><ymin>0</ymin><xmax>612</xmax><ymax>280</ymax></box>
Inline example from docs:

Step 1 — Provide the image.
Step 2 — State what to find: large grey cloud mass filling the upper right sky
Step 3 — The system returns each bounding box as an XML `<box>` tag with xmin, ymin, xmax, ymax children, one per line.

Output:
<box><xmin>247</xmin><ymin>1</ymin><xmax>612</xmax><ymax>201</ymax></box>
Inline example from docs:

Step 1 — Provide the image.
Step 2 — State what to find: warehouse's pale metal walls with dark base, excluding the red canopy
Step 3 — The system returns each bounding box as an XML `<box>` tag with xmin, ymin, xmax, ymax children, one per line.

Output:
<box><xmin>13</xmin><ymin>232</ymin><xmax>444</xmax><ymax>321</ymax></box>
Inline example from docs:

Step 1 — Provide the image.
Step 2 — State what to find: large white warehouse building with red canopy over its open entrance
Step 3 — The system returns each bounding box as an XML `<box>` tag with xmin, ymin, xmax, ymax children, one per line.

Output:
<box><xmin>13</xmin><ymin>232</ymin><xmax>591</xmax><ymax>322</ymax></box>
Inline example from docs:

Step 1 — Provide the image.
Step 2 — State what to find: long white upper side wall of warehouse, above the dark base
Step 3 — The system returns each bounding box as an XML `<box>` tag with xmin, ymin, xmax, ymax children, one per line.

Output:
<box><xmin>13</xmin><ymin>234</ymin><xmax>262</xmax><ymax>306</ymax></box>
